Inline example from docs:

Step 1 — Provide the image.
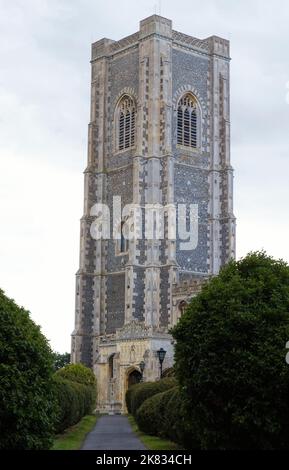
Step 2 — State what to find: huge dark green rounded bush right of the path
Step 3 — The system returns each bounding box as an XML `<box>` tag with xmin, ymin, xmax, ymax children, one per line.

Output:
<box><xmin>173</xmin><ymin>252</ymin><xmax>289</xmax><ymax>449</ymax></box>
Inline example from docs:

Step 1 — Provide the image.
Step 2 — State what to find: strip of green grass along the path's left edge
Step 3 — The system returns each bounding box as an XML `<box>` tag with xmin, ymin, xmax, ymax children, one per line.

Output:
<box><xmin>52</xmin><ymin>415</ymin><xmax>97</xmax><ymax>450</ymax></box>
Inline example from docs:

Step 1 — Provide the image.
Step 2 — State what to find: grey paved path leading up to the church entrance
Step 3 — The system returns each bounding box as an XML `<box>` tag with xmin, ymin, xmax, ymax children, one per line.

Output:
<box><xmin>82</xmin><ymin>415</ymin><xmax>145</xmax><ymax>450</ymax></box>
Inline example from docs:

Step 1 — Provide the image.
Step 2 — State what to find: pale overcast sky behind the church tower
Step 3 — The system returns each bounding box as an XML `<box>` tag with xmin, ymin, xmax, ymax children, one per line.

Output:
<box><xmin>0</xmin><ymin>0</ymin><xmax>289</xmax><ymax>352</ymax></box>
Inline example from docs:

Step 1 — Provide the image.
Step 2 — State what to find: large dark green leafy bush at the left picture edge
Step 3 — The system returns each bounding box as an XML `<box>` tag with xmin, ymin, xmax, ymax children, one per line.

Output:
<box><xmin>0</xmin><ymin>290</ymin><xmax>55</xmax><ymax>450</ymax></box>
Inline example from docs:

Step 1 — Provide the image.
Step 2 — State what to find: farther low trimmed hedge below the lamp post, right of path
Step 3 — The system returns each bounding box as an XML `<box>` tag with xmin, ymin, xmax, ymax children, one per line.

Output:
<box><xmin>126</xmin><ymin>377</ymin><xmax>177</xmax><ymax>416</ymax></box>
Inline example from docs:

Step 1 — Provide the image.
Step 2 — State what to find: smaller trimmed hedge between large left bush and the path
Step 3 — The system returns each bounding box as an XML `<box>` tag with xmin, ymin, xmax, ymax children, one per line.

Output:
<box><xmin>54</xmin><ymin>364</ymin><xmax>96</xmax><ymax>433</ymax></box>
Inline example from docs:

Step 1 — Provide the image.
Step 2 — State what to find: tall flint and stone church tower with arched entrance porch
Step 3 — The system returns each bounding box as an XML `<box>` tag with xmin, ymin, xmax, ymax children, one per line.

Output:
<box><xmin>72</xmin><ymin>15</ymin><xmax>235</xmax><ymax>412</ymax></box>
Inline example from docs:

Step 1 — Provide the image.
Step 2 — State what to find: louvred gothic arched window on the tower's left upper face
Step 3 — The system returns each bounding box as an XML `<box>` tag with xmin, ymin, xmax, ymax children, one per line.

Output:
<box><xmin>117</xmin><ymin>95</ymin><xmax>136</xmax><ymax>150</ymax></box>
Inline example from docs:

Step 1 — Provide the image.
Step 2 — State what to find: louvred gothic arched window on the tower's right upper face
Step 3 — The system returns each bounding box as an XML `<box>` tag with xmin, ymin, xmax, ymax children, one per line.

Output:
<box><xmin>177</xmin><ymin>93</ymin><xmax>199</xmax><ymax>149</ymax></box>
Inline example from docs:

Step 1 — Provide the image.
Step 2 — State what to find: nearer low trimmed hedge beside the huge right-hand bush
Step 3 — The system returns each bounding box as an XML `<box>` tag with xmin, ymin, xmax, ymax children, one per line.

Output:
<box><xmin>136</xmin><ymin>387</ymin><xmax>192</xmax><ymax>448</ymax></box>
